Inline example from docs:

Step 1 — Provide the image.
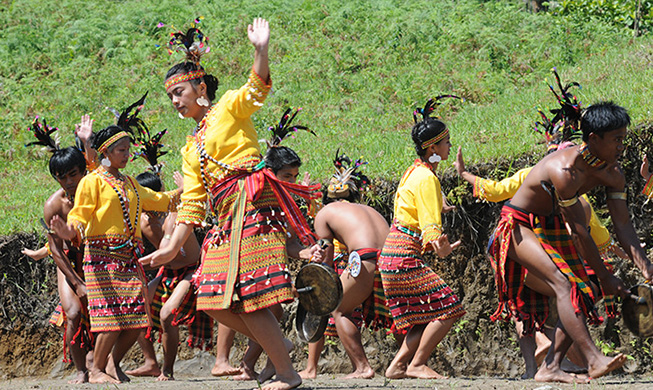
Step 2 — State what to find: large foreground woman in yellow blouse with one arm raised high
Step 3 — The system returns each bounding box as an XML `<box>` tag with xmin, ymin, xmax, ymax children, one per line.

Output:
<box><xmin>141</xmin><ymin>18</ymin><xmax>319</xmax><ymax>390</ymax></box>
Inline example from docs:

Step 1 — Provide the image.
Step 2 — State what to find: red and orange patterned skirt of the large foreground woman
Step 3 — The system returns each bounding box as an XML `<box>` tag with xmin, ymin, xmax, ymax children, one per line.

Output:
<box><xmin>195</xmin><ymin>183</ymin><xmax>293</xmax><ymax>314</ymax></box>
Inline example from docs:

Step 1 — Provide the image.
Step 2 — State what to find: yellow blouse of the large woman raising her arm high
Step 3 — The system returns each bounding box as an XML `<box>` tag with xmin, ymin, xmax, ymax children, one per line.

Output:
<box><xmin>177</xmin><ymin>70</ymin><xmax>271</xmax><ymax>226</ymax></box>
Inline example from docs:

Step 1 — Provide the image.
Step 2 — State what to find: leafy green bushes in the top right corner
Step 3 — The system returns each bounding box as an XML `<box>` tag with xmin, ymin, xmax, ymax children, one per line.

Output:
<box><xmin>548</xmin><ymin>0</ymin><xmax>653</xmax><ymax>31</ymax></box>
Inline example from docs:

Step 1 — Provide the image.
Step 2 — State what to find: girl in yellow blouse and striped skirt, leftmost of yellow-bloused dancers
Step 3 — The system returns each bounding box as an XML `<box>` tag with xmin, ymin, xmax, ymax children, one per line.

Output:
<box><xmin>51</xmin><ymin>126</ymin><xmax>177</xmax><ymax>383</ymax></box>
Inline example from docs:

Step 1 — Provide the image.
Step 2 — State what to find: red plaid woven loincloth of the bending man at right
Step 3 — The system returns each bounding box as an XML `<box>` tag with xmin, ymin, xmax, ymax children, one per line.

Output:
<box><xmin>489</xmin><ymin>202</ymin><xmax>602</xmax><ymax>334</ymax></box>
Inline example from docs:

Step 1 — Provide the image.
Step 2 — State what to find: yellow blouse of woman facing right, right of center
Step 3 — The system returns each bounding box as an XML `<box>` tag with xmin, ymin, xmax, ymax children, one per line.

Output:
<box><xmin>394</xmin><ymin>160</ymin><xmax>442</xmax><ymax>251</ymax></box>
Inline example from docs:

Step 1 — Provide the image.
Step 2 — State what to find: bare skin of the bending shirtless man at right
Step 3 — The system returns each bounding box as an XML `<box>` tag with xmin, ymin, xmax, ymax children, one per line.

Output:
<box><xmin>508</xmin><ymin>128</ymin><xmax>653</xmax><ymax>382</ymax></box>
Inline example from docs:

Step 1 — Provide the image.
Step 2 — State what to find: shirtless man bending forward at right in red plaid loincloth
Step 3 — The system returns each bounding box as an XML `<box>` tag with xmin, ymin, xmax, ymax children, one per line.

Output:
<box><xmin>490</xmin><ymin>103</ymin><xmax>653</xmax><ymax>382</ymax></box>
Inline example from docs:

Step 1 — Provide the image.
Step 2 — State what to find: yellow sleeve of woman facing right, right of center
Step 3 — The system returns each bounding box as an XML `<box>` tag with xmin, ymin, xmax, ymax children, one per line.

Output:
<box><xmin>415</xmin><ymin>175</ymin><xmax>442</xmax><ymax>250</ymax></box>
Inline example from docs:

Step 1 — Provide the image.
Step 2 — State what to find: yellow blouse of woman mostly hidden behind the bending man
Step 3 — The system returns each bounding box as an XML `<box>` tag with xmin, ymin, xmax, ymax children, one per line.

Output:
<box><xmin>474</xmin><ymin>167</ymin><xmax>615</xmax><ymax>255</ymax></box>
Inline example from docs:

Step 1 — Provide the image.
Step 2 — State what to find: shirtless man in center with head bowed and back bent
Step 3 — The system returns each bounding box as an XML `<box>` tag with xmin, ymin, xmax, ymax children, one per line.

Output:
<box><xmin>300</xmin><ymin>155</ymin><xmax>391</xmax><ymax>379</ymax></box>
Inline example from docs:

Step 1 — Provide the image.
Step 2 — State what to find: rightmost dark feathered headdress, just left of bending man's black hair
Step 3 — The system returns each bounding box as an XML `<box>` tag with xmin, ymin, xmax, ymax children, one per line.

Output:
<box><xmin>535</xmin><ymin>68</ymin><xmax>582</xmax><ymax>151</ymax></box>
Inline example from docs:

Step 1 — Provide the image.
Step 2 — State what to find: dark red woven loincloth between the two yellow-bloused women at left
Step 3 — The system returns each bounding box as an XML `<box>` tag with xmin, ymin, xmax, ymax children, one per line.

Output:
<box><xmin>152</xmin><ymin>265</ymin><xmax>213</xmax><ymax>351</ymax></box>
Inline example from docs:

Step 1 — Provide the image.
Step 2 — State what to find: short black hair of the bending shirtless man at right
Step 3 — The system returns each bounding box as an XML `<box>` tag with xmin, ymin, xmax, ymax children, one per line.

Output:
<box><xmin>580</xmin><ymin>102</ymin><xmax>630</xmax><ymax>141</ymax></box>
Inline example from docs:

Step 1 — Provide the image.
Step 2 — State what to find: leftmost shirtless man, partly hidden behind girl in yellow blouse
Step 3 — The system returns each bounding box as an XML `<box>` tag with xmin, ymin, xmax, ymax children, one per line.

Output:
<box><xmin>33</xmin><ymin>115</ymin><xmax>95</xmax><ymax>383</ymax></box>
